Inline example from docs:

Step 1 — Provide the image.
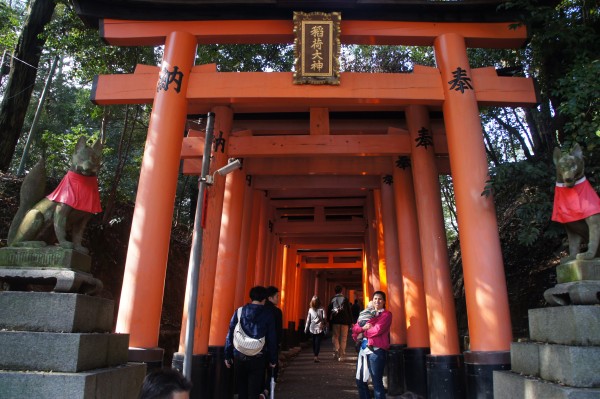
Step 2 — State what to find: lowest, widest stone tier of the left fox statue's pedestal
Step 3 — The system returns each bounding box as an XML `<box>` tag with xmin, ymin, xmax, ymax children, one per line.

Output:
<box><xmin>0</xmin><ymin>363</ymin><xmax>146</xmax><ymax>399</ymax></box>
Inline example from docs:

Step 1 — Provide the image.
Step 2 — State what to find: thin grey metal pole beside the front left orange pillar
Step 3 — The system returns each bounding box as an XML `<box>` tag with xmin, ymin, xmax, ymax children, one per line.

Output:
<box><xmin>183</xmin><ymin>112</ymin><xmax>215</xmax><ymax>381</ymax></box>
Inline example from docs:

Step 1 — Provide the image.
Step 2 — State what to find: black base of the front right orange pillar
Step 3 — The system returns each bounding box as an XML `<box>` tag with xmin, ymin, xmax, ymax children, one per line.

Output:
<box><xmin>464</xmin><ymin>351</ymin><xmax>510</xmax><ymax>399</ymax></box>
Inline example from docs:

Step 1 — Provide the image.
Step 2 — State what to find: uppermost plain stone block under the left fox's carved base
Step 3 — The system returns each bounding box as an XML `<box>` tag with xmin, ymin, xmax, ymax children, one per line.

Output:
<box><xmin>0</xmin><ymin>291</ymin><xmax>114</xmax><ymax>333</ymax></box>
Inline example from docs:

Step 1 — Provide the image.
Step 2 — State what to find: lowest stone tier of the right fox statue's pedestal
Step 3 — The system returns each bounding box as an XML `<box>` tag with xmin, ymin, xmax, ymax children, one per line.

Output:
<box><xmin>494</xmin><ymin>371</ymin><xmax>600</xmax><ymax>399</ymax></box>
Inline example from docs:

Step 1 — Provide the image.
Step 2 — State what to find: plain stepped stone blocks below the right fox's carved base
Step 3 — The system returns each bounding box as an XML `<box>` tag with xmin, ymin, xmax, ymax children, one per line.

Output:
<box><xmin>494</xmin><ymin>306</ymin><xmax>600</xmax><ymax>399</ymax></box>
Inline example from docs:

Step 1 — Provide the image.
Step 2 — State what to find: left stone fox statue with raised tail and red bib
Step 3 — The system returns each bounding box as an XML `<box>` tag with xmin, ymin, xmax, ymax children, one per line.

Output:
<box><xmin>8</xmin><ymin>136</ymin><xmax>102</xmax><ymax>254</ymax></box>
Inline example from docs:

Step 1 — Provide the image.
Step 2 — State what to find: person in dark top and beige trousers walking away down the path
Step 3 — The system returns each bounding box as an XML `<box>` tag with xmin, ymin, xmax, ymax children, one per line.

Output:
<box><xmin>327</xmin><ymin>285</ymin><xmax>352</xmax><ymax>362</ymax></box>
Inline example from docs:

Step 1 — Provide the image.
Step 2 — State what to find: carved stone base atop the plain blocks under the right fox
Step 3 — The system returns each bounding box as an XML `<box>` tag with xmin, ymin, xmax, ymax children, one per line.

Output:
<box><xmin>544</xmin><ymin>280</ymin><xmax>600</xmax><ymax>306</ymax></box>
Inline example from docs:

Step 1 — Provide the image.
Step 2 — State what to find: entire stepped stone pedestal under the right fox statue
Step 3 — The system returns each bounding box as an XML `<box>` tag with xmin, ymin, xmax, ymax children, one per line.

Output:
<box><xmin>494</xmin><ymin>259</ymin><xmax>600</xmax><ymax>399</ymax></box>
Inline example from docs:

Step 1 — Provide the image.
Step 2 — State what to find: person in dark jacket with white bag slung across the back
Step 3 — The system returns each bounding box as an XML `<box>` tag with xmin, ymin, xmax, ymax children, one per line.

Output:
<box><xmin>225</xmin><ymin>286</ymin><xmax>277</xmax><ymax>399</ymax></box>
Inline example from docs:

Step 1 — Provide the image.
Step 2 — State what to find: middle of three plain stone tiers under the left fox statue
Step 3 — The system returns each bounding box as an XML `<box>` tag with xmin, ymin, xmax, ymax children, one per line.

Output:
<box><xmin>0</xmin><ymin>331</ymin><xmax>129</xmax><ymax>374</ymax></box>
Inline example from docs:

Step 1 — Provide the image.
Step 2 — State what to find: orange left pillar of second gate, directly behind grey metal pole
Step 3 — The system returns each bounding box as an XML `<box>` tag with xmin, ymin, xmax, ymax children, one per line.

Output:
<box><xmin>179</xmin><ymin>106</ymin><xmax>233</xmax><ymax>355</ymax></box>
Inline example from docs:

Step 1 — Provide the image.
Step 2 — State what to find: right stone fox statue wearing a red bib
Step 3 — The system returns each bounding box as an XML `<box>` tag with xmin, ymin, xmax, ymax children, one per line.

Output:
<box><xmin>552</xmin><ymin>144</ymin><xmax>600</xmax><ymax>262</ymax></box>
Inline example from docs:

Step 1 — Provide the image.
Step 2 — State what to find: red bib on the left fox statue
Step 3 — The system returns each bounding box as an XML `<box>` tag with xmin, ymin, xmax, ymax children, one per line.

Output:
<box><xmin>46</xmin><ymin>171</ymin><xmax>102</xmax><ymax>213</ymax></box>
